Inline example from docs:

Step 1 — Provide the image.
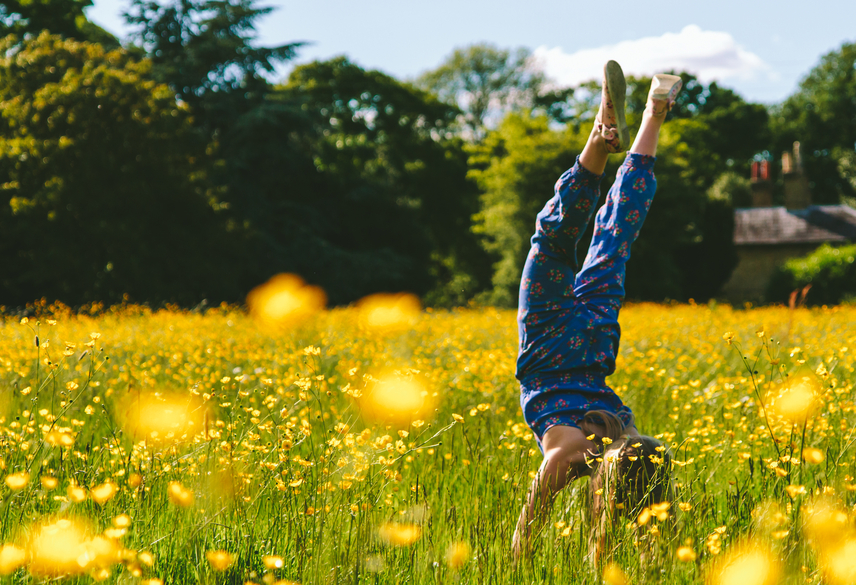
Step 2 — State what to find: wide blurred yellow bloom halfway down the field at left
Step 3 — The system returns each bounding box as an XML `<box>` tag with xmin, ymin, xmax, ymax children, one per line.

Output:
<box><xmin>120</xmin><ymin>393</ymin><xmax>205</xmax><ymax>442</ymax></box>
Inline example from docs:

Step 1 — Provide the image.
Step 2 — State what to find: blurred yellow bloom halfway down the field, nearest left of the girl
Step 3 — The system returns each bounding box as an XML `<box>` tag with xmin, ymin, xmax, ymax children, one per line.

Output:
<box><xmin>360</xmin><ymin>372</ymin><xmax>431</xmax><ymax>423</ymax></box>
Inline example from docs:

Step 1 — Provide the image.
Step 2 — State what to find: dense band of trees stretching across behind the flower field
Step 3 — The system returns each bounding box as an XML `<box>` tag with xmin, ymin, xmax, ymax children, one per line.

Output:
<box><xmin>0</xmin><ymin>0</ymin><xmax>856</xmax><ymax>306</ymax></box>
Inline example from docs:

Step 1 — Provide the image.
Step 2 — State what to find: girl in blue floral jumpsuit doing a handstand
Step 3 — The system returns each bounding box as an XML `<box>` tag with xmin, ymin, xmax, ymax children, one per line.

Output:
<box><xmin>513</xmin><ymin>61</ymin><xmax>681</xmax><ymax>557</ymax></box>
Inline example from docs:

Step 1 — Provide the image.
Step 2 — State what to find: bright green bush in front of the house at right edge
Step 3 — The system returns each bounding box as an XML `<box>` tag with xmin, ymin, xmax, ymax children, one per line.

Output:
<box><xmin>767</xmin><ymin>244</ymin><xmax>856</xmax><ymax>305</ymax></box>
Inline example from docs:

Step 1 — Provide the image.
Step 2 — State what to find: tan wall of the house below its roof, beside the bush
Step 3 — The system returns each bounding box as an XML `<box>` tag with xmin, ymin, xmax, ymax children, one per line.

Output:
<box><xmin>719</xmin><ymin>244</ymin><xmax>818</xmax><ymax>303</ymax></box>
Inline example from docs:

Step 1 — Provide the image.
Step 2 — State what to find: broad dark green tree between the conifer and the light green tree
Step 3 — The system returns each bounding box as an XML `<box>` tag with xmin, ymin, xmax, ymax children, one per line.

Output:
<box><xmin>260</xmin><ymin>58</ymin><xmax>487</xmax><ymax>303</ymax></box>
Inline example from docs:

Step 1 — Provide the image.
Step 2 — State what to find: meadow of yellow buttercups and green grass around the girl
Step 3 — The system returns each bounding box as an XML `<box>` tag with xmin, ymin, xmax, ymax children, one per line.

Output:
<box><xmin>0</xmin><ymin>286</ymin><xmax>856</xmax><ymax>585</ymax></box>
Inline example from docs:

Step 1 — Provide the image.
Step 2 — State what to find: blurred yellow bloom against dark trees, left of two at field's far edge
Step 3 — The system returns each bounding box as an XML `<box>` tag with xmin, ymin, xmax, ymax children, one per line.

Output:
<box><xmin>247</xmin><ymin>274</ymin><xmax>327</xmax><ymax>330</ymax></box>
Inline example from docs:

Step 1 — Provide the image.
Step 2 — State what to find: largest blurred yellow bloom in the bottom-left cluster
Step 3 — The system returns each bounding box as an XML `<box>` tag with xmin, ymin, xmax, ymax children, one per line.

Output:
<box><xmin>27</xmin><ymin>518</ymin><xmax>89</xmax><ymax>577</ymax></box>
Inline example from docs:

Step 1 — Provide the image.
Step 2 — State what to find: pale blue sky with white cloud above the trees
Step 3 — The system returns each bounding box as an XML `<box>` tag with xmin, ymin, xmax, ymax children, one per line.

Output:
<box><xmin>87</xmin><ymin>0</ymin><xmax>856</xmax><ymax>104</ymax></box>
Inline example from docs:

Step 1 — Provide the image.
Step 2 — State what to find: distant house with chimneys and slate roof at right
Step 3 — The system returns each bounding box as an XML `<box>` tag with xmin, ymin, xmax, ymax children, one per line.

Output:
<box><xmin>721</xmin><ymin>142</ymin><xmax>856</xmax><ymax>302</ymax></box>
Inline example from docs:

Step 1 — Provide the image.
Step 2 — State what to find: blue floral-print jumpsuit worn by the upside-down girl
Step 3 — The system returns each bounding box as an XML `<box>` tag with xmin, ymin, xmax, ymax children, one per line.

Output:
<box><xmin>516</xmin><ymin>153</ymin><xmax>657</xmax><ymax>445</ymax></box>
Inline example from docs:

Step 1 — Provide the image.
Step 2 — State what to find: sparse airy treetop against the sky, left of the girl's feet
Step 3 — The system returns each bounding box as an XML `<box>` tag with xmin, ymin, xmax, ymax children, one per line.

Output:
<box><xmin>416</xmin><ymin>43</ymin><xmax>548</xmax><ymax>138</ymax></box>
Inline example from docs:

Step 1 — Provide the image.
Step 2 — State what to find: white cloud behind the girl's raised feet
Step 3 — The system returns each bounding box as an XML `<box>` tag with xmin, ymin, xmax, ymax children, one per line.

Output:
<box><xmin>534</xmin><ymin>24</ymin><xmax>776</xmax><ymax>86</ymax></box>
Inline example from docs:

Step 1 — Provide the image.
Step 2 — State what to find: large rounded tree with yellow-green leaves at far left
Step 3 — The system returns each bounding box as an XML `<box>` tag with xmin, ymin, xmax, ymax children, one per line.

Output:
<box><xmin>0</xmin><ymin>33</ymin><xmax>236</xmax><ymax>305</ymax></box>
